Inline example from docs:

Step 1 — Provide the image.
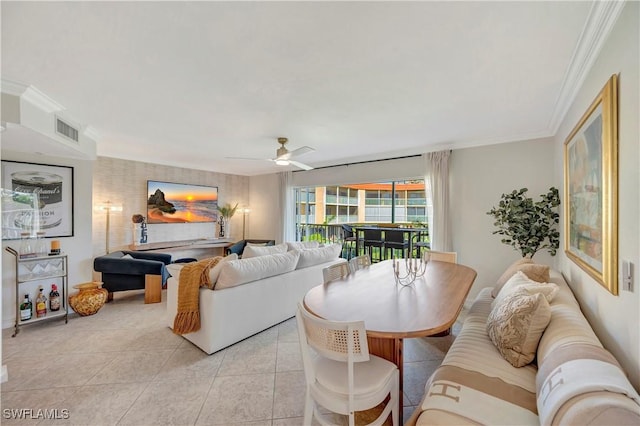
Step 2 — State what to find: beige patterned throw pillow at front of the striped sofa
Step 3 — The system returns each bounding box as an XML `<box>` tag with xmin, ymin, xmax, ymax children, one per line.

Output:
<box><xmin>487</xmin><ymin>289</ymin><xmax>551</xmax><ymax>367</ymax></box>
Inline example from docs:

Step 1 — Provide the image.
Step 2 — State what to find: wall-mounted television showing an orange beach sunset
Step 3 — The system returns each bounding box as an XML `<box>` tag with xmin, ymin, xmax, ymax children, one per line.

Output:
<box><xmin>147</xmin><ymin>180</ymin><xmax>218</xmax><ymax>223</ymax></box>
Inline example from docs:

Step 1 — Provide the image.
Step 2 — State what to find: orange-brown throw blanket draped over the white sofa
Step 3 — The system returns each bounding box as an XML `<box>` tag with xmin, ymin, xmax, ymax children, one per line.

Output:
<box><xmin>173</xmin><ymin>256</ymin><xmax>222</xmax><ymax>334</ymax></box>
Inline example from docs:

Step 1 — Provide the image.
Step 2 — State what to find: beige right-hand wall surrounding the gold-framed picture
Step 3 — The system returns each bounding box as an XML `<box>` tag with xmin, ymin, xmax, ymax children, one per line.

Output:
<box><xmin>555</xmin><ymin>2</ymin><xmax>640</xmax><ymax>389</ymax></box>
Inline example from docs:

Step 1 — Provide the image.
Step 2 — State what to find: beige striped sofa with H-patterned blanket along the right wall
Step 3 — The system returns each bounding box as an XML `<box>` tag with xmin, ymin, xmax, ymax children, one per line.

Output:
<box><xmin>407</xmin><ymin>270</ymin><xmax>640</xmax><ymax>425</ymax></box>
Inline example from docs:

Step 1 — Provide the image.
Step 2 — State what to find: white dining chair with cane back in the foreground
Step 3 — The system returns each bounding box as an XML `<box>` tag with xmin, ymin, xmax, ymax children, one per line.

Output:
<box><xmin>296</xmin><ymin>303</ymin><xmax>400</xmax><ymax>426</ymax></box>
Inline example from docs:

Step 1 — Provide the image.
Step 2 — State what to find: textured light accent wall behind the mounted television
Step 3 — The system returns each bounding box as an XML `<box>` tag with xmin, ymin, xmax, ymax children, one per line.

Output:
<box><xmin>92</xmin><ymin>157</ymin><xmax>249</xmax><ymax>256</ymax></box>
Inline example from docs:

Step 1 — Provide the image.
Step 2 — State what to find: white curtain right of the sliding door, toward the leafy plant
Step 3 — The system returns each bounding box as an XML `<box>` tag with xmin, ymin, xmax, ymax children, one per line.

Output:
<box><xmin>424</xmin><ymin>150</ymin><xmax>453</xmax><ymax>251</ymax></box>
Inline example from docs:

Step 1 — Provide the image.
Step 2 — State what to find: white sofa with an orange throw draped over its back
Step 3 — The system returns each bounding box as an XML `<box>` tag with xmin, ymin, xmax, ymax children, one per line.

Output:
<box><xmin>167</xmin><ymin>243</ymin><xmax>346</xmax><ymax>354</ymax></box>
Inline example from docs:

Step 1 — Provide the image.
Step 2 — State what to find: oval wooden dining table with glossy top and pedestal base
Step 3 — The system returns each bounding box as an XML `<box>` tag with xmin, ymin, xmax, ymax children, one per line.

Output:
<box><xmin>304</xmin><ymin>260</ymin><xmax>476</xmax><ymax>422</ymax></box>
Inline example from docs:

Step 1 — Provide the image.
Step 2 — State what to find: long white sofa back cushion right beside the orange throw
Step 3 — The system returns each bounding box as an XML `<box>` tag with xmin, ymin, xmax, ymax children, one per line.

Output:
<box><xmin>214</xmin><ymin>250</ymin><xmax>300</xmax><ymax>290</ymax></box>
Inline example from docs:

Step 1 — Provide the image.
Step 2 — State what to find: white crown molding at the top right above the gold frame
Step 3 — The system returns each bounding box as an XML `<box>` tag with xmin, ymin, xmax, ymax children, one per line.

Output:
<box><xmin>549</xmin><ymin>0</ymin><xmax>626</xmax><ymax>135</ymax></box>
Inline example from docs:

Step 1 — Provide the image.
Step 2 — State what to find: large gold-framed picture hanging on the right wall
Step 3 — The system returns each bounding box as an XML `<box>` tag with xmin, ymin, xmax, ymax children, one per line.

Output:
<box><xmin>564</xmin><ymin>75</ymin><xmax>618</xmax><ymax>295</ymax></box>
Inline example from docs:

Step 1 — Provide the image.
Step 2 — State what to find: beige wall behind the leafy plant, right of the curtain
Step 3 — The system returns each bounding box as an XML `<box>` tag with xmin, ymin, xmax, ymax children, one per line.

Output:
<box><xmin>449</xmin><ymin>138</ymin><xmax>554</xmax><ymax>302</ymax></box>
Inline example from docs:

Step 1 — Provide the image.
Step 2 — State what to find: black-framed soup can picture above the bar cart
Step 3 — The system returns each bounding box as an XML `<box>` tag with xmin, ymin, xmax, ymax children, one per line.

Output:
<box><xmin>2</xmin><ymin>161</ymin><xmax>73</xmax><ymax>240</ymax></box>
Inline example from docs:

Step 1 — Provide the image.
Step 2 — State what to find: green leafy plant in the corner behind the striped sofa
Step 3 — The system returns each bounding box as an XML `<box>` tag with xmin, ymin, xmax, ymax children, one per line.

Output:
<box><xmin>487</xmin><ymin>187</ymin><xmax>560</xmax><ymax>258</ymax></box>
